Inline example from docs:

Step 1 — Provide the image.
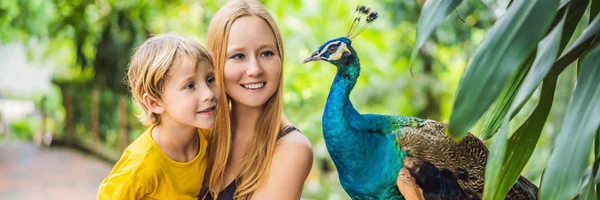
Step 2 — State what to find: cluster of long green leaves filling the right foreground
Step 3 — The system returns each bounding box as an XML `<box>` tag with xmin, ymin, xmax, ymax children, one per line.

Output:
<box><xmin>419</xmin><ymin>0</ymin><xmax>600</xmax><ymax>199</ymax></box>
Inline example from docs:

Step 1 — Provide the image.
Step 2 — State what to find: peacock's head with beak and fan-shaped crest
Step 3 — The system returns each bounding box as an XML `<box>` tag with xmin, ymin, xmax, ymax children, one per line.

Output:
<box><xmin>302</xmin><ymin>6</ymin><xmax>379</xmax><ymax>66</ymax></box>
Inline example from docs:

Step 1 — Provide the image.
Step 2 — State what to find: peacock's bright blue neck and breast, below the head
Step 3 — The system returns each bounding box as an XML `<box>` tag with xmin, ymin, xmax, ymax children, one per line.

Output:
<box><xmin>322</xmin><ymin>44</ymin><xmax>404</xmax><ymax>199</ymax></box>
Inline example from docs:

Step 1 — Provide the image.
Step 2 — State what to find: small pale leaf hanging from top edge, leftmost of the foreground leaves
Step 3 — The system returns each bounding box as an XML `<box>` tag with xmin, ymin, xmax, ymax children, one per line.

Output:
<box><xmin>409</xmin><ymin>0</ymin><xmax>462</xmax><ymax>69</ymax></box>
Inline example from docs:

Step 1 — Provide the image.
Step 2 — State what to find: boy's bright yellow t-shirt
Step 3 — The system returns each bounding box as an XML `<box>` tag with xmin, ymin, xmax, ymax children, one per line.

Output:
<box><xmin>98</xmin><ymin>127</ymin><xmax>208</xmax><ymax>200</ymax></box>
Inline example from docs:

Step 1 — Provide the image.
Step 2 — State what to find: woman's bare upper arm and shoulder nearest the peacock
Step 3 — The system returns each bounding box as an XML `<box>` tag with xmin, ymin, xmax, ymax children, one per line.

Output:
<box><xmin>252</xmin><ymin>131</ymin><xmax>313</xmax><ymax>199</ymax></box>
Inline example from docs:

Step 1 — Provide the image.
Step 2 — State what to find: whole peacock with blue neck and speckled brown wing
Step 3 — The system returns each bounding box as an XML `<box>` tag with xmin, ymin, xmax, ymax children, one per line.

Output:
<box><xmin>302</xmin><ymin>6</ymin><xmax>538</xmax><ymax>199</ymax></box>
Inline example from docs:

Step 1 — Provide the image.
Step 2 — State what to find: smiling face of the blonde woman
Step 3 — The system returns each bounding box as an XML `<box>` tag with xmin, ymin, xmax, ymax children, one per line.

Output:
<box><xmin>224</xmin><ymin>16</ymin><xmax>282</xmax><ymax>107</ymax></box>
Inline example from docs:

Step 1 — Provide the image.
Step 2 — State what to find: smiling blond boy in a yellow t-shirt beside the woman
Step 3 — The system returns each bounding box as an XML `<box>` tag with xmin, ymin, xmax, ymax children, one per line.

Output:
<box><xmin>98</xmin><ymin>34</ymin><xmax>218</xmax><ymax>199</ymax></box>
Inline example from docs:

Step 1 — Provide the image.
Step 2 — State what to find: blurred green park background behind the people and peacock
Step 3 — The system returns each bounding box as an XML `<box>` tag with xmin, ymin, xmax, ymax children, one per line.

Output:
<box><xmin>0</xmin><ymin>0</ymin><xmax>581</xmax><ymax>200</ymax></box>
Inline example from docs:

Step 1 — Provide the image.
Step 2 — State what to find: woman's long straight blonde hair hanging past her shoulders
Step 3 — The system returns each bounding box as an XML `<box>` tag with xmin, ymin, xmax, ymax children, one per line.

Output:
<box><xmin>204</xmin><ymin>0</ymin><xmax>284</xmax><ymax>199</ymax></box>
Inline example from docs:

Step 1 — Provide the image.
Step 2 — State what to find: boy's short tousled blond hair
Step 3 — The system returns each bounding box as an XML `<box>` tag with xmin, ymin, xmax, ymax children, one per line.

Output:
<box><xmin>127</xmin><ymin>34</ymin><xmax>213</xmax><ymax>125</ymax></box>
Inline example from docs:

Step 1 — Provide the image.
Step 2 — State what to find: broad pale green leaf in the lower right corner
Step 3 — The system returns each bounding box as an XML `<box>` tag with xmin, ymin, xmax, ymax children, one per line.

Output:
<box><xmin>540</xmin><ymin>43</ymin><xmax>600</xmax><ymax>199</ymax></box>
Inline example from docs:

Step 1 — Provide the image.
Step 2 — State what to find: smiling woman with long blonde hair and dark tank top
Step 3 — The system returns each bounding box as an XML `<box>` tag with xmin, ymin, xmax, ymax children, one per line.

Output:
<box><xmin>201</xmin><ymin>0</ymin><xmax>313</xmax><ymax>199</ymax></box>
